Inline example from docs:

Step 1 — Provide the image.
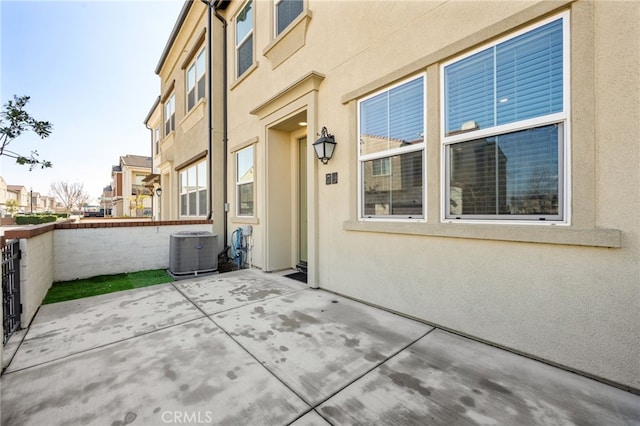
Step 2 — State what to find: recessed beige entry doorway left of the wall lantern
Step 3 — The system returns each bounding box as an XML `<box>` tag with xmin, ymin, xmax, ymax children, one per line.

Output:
<box><xmin>265</xmin><ymin>111</ymin><xmax>310</xmax><ymax>273</ymax></box>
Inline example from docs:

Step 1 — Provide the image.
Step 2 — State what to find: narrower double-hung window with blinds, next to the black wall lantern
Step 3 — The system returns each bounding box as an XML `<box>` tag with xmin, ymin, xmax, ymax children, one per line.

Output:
<box><xmin>358</xmin><ymin>76</ymin><xmax>425</xmax><ymax>219</ymax></box>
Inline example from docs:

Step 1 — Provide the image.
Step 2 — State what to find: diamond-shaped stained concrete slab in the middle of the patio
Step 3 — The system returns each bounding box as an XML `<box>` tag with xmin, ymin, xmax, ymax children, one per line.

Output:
<box><xmin>212</xmin><ymin>290</ymin><xmax>432</xmax><ymax>405</ymax></box>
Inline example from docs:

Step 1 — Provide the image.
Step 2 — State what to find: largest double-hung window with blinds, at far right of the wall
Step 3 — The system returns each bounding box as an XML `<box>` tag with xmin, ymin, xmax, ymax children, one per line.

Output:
<box><xmin>442</xmin><ymin>15</ymin><xmax>569</xmax><ymax>221</ymax></box>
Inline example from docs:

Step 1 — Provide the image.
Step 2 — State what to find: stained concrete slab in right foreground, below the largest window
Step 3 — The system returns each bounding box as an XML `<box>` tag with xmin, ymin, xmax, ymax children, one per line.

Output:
<box><xmin>319</xmin><ymin>330</ymin><xmax>640</xmax><ymax>426</ymax></box>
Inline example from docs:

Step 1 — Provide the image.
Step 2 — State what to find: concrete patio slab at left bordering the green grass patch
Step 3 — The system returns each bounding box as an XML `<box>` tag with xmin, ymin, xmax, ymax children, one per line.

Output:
<box><xmin>7</xmin><ymin>284</ymin><xmax>204</xmax><ymax>371</ymax></box>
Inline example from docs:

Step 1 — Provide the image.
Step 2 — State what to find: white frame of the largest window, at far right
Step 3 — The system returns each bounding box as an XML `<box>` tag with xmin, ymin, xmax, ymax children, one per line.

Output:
<box><xmin>440</xmin><ymin>12</ymin><xmax>571</xmax><ymax>225</ymax></box>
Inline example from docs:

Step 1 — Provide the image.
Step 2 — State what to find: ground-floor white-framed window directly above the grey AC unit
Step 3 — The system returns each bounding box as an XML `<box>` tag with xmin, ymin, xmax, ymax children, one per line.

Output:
<box><xmin>179</xmin><ymin>160</ymin><xmax>207</xmax><ymax>216</ymax></box>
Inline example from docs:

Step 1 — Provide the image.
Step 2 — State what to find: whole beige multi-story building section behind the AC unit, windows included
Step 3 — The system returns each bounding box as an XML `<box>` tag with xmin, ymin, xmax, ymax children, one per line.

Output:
<box><xmin>145</xmin><ymin>1</ymin><xmax>224</xmax><ymax>249</ymax></box>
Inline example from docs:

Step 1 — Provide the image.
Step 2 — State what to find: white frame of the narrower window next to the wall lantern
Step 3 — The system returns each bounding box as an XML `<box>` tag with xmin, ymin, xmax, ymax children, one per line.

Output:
<box><xmin>357</xmin><ymin>73</ymin><xmax>427</xmax><ymax>222</ymax></box>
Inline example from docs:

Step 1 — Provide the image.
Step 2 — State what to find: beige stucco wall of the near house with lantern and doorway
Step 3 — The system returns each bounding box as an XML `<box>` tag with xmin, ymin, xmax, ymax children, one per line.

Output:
<box><xmin>210</xmin><ymin>0</ymin><xmax>640</xmax><ymax>390</ymax></box>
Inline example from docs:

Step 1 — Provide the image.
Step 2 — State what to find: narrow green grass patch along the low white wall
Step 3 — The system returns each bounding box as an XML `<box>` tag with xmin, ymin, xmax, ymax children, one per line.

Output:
<box><xmin>42</xmin><ymin>269</ymin><xmax>173</xmax><ymax>305</ymax></box>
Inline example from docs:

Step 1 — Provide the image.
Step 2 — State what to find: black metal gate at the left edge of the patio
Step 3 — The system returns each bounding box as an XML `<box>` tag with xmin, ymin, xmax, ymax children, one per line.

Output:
<box><xmin>2</xmin><ymin>240</ymin><xmax>22</xmax><ymax>345</ymax></box>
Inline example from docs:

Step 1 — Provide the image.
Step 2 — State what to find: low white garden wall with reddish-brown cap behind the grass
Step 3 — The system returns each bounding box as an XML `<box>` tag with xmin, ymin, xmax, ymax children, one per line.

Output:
<box><xmin>5</xmin><ymin>220</ymin><xmax>212</xmax><ymax>328</ymax></box>
